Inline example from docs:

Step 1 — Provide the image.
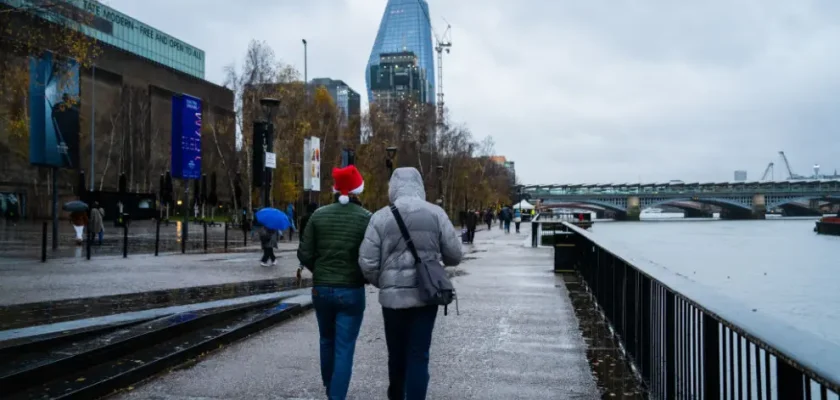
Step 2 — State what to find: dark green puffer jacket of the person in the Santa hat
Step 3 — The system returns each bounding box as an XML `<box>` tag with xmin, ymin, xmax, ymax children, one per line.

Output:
<box><xmin>297</xmin><ymin>202</ymin><xmax>371</xmax><ymax>287</ymax></box>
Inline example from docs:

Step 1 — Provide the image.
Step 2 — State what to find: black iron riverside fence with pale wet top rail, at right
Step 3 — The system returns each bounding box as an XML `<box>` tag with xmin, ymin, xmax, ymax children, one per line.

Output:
<box><xmin>555</xmin><ymin>223</ymin><xmax>840</xmax><ymax>400</ymax></box>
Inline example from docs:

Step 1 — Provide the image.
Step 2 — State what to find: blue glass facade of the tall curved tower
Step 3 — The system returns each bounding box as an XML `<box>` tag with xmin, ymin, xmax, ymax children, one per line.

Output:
<box><xmin>365</xmin><ymin>0</ymin><xmax>435</xmax><ymax>103</ymax></box>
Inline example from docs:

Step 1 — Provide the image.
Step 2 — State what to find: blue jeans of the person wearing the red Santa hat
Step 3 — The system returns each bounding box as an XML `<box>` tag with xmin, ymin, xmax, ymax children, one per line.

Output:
<box><xmin>312</xmin><ymin>286</ymin><xmax>365</xmax><ymax>400</ymax></box>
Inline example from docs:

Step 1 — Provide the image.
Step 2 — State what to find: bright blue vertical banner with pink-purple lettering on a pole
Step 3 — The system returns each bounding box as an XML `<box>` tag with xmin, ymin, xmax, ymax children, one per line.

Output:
<box><xmin>171</xmin><ymin>94</ymin><xmax>201</xmax><ymax>179</ymax></box>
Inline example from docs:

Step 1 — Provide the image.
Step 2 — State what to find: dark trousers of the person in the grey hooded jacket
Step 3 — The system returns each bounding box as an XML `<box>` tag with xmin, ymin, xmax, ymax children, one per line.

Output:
<box><xmin>382</xmin><ymin>306</ymin><xmax>438</xmax><ymax>400</ymax></box>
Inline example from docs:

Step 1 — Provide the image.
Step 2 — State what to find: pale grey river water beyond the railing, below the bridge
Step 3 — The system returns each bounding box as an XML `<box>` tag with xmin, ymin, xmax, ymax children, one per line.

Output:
<box><xmin>592</xmin><ymin>216</ymin><xmax>840</xmax><ymax>345</ymax></box>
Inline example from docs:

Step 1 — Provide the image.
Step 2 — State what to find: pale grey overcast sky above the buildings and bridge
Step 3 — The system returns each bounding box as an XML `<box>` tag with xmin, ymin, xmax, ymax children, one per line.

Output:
<box><xmin>105</xmin><ymin>0</ymin><xmax>840</xmax><ymax>183</ymax></box>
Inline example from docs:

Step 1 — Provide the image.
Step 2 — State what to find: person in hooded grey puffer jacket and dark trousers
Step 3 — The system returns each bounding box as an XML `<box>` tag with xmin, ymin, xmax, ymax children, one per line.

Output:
<box><xmin>359</xmin><ymin>168</ymin><xmax>463</xmax><ymax>400</ymax></box>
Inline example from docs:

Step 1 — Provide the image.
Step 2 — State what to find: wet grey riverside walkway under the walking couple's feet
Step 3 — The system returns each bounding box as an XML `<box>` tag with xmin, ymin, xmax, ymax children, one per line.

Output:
<box><xmin>117</xmin><ymin>224</ymin><xmax>600</xmax><ymax>400</ymax></box>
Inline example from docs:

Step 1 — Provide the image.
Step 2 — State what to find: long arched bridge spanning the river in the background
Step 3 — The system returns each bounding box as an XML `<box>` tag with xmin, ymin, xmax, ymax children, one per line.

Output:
<box><xmin>522</xmin><ymin>179</ymin><xmax>840</xmax><ymax>220</ymax></box>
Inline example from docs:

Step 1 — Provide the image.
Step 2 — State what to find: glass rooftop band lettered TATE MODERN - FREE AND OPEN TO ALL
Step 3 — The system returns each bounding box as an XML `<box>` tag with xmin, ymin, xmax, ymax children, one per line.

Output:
<box><xmin>0</xmin><ymin>0</ymin><xmax>204</xmax><ymax>79</ymax></box>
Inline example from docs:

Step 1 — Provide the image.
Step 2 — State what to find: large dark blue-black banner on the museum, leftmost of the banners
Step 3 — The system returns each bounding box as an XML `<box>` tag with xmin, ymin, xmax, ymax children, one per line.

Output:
<box><xmin>29</xmin><ymin>53</ymin><xmax>80</xmax><ymax>169</ymax></box>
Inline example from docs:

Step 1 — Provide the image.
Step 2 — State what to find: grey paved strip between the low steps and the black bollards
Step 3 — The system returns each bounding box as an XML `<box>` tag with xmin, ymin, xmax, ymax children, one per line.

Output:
<box><xmin>0</xmin><ymin>242</ymin><xmax>311</xmax><ymax>306</ymax></box>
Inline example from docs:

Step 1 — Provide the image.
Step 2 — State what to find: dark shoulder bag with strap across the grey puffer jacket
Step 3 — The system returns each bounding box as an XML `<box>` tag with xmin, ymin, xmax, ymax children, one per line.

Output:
<box><xmin>391</xmin><ymin>204</ymin><xmax>459</xmax><ymax>315</ymax></box>
